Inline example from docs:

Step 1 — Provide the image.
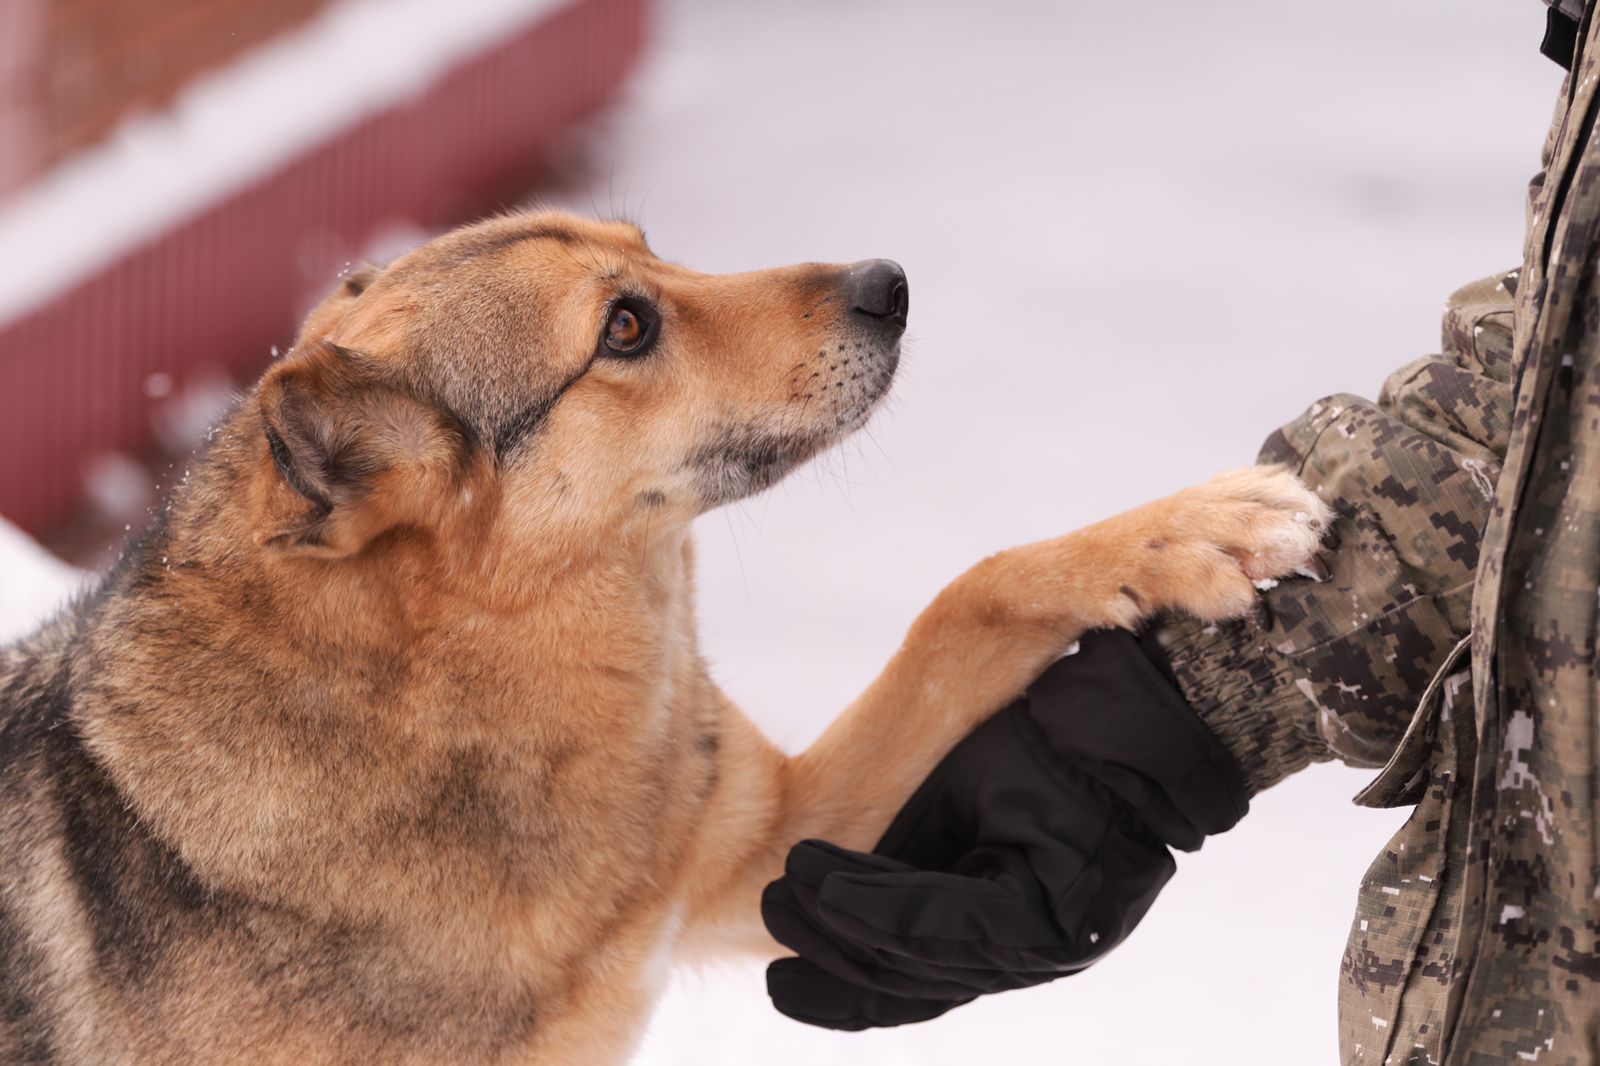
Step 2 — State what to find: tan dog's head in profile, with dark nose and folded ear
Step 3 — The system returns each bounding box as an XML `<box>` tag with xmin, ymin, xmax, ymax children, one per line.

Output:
<box><xmin>254</xmin><ymin>213</ymin><xmax>907</xmax><ymax>555</ymax></box>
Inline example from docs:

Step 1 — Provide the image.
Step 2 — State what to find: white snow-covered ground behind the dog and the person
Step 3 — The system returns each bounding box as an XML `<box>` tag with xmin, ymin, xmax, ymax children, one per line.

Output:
<box><xmin>0</xmin><ymin>0</ymin><xmax>1560</xmax><ymax>1066</ymax></box>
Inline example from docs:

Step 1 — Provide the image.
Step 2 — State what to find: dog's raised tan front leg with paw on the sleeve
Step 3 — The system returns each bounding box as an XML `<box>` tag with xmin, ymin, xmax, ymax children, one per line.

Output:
<box><xmin>694</xmin><ymin>467</ymin><xmax>1330</xmax><ymax>951</ymax></box>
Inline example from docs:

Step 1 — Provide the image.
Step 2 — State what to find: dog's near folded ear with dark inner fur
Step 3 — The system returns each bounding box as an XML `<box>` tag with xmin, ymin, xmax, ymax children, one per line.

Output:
<box><xmin>253</xmin><ymin>341</ymin><xmax>472</xmax><ymax>559</ymax></box>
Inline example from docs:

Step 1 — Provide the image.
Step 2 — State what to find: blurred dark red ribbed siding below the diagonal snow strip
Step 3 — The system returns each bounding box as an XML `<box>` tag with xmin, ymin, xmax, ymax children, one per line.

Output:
<box><xmin>0</xmin><ymin>0</ymin><xmax>646</xmax><ymax>535</ymax></box>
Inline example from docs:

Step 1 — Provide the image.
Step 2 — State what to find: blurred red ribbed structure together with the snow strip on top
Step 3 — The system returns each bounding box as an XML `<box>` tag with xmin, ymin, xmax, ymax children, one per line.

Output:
<box><xmin>0</xmin><ymin>0</ymin><xmax>646</xmax><ymax>533</ymax></box>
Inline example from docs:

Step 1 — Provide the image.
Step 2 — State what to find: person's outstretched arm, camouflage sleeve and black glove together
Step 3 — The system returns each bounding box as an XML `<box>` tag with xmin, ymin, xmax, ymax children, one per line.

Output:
<box><xmin>762</xmin><ymin>270</ymin><xmax>1515</xmax><ymax>1029</ymax></box>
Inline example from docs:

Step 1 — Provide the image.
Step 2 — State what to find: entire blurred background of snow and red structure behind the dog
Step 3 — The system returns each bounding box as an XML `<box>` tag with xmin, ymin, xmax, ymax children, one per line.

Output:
<box><xmin>0</xmin><ymin>0</ymin><xmax>1560</xmax><ymax>1066</ymax></box>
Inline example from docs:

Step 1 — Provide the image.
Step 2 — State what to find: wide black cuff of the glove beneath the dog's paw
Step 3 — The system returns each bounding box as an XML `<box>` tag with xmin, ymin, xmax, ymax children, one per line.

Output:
<box><xmin>1027</xmin><ymin>629</ymin><xmax>1250</xmax><ymax>852</ymax></box>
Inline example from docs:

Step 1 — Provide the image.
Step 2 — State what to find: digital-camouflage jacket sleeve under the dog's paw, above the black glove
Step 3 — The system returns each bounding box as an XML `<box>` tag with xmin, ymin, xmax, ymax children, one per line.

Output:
<box><xmin>1163</xmin><ymin>272</ymin><xmax>1517</xmax><ymax>794</ymax></box>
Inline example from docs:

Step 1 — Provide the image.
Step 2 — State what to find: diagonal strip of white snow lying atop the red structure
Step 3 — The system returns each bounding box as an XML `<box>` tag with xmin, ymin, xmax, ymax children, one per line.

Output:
<box><xmin>0</xmin><ymin>0</ymin><xmax>568</xmax><ymax>322</ymax></box>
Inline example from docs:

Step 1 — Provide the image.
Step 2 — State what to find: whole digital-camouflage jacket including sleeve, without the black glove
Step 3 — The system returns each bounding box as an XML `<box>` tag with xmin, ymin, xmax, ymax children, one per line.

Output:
<box><xmin>1171</xmin><ymin>14</ymin><xmax>1600</xmax><ymax>1066</ymax></box>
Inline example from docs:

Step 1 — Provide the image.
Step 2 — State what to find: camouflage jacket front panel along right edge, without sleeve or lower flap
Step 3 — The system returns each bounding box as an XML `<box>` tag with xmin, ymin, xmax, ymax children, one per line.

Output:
<box><xmin>1446</xmin><ymin>4</ymin><xmax>1600</xmax><ymax>1066</ymax></box>
